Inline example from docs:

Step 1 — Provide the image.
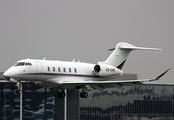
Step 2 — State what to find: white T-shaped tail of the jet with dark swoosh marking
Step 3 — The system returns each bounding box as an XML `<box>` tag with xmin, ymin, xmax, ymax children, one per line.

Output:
<box><xmin>98</xmin><ymin>42</ymin><xmax>161</xmax><ymax>70</ymax></box>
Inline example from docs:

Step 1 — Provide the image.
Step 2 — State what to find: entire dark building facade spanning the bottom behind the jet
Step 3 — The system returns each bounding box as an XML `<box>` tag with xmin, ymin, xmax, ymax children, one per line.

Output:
<box><xmin>0</xmin><ymin>72</ymin><xmax>174</xmax><ymax>120</ymax></box>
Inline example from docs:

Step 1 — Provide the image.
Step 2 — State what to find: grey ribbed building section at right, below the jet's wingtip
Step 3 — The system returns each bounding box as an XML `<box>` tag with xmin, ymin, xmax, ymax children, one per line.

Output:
<box><xmin>80</xmin><ymin>84</ymin><xmax>174</xmax><ymax>120</ymax></box>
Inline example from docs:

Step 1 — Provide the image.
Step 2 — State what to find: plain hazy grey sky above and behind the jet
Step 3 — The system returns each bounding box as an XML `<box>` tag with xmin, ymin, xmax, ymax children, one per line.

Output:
<box><xmin>0</xmin><ymin>0</ymin><xmax>174</xmax><ymax>83</ymax></box>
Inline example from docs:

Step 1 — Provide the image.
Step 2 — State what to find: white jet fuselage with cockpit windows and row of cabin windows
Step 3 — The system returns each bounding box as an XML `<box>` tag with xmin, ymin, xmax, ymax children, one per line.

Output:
<box><xmin>4</xmin><ymin>59</ymin><xmax>123</xmax><ymax>83</ymax></box>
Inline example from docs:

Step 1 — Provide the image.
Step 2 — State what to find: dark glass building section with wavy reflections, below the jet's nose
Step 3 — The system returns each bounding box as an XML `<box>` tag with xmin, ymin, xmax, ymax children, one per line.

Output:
<box><xmin>0</xmin><ymin>73</ymin><xmax>55</xmax><ymax>120</ymax></box>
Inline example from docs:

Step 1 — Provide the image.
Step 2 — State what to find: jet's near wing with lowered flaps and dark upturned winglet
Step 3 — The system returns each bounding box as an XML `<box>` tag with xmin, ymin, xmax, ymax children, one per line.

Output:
<box><xmin>58</xmin><ymin>69</ymin><xmax>169</xmax><ymax>91</ymax></box>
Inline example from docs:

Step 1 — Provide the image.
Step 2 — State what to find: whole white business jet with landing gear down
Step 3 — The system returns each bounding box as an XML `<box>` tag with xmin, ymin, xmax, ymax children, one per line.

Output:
<box><xmin>3</xmin><ymin>42</ymin><xmax>169</xmax><ymax>98</ymax></box>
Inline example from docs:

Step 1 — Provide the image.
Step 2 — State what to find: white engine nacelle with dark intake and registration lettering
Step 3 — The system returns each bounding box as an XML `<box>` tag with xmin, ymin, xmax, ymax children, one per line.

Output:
<box><xmin>94</xmin><ymin>64</ymin><xmax>123</xmax><ymax>77</ymax></box>
